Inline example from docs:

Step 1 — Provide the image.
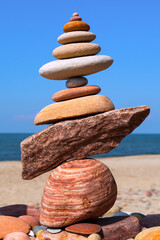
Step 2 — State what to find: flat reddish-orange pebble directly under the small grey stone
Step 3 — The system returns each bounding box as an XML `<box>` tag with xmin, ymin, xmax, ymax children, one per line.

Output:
<box><xmin>52</xmin><ymin>86</ymin><xmax>101</xmax><ymax>102</ymax></box>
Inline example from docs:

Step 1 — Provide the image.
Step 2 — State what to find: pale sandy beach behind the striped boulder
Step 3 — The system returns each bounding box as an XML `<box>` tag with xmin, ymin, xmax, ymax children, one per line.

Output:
<box><xmin>0</xmin><ymin>155</ymin><xmax>160</xmax><ymax>214</ymax></box>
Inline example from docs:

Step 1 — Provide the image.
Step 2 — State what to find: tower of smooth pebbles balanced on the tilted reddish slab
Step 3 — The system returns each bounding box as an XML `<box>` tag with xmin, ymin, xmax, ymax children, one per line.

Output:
<box><xmin>35</xmin><ymin>13</ymin><xmax>114</xmax><ymax>125</ymax></box>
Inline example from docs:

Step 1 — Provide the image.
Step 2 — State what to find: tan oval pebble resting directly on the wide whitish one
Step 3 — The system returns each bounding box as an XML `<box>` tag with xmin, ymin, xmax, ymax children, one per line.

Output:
<box><xmin>52</xmin><ymin>42</ymin><xmax>101</xmax><ymax>59</ymax></box>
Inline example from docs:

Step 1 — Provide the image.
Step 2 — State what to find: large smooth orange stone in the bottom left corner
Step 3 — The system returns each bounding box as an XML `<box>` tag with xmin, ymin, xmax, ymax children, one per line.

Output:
<box><xmin>0</xmin><ymin>216</ymin><xmax>30</xmax><ymax>239</ymax></box>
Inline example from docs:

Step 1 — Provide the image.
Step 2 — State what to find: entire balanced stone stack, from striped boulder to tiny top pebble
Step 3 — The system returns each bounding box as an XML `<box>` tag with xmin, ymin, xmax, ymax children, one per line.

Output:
<box><xmin>21</xmin><ymin>13</ymin><xmax>149</xmax><ymax>237</ymax></box>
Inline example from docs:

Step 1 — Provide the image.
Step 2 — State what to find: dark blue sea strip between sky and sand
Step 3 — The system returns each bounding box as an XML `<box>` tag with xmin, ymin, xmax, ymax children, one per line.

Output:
<box><xmin>0</xmin><ymin>133</ymin><xmax>160</xmax><ymax>161</ymax></box>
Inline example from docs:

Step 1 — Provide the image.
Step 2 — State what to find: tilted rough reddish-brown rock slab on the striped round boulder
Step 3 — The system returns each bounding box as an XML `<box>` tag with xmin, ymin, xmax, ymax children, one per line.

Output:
<box><xmin>21</xmin><ymin>106</ymin><xmax>150</xmax><ymax>179</ymax></box>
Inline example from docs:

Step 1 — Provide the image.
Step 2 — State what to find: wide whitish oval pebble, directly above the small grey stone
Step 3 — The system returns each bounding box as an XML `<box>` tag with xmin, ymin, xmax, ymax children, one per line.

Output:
<box><xmin>39</xmin><ymin>55</ymin><xmax>113</xmax><ymax>80</ymax></box>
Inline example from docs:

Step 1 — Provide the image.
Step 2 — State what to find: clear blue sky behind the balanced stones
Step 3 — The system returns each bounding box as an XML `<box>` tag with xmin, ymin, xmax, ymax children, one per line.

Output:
<box><xmin>0</xmin><ymin>0</ymin><xmax>160</xmax><ymax>133</ymax></box>
